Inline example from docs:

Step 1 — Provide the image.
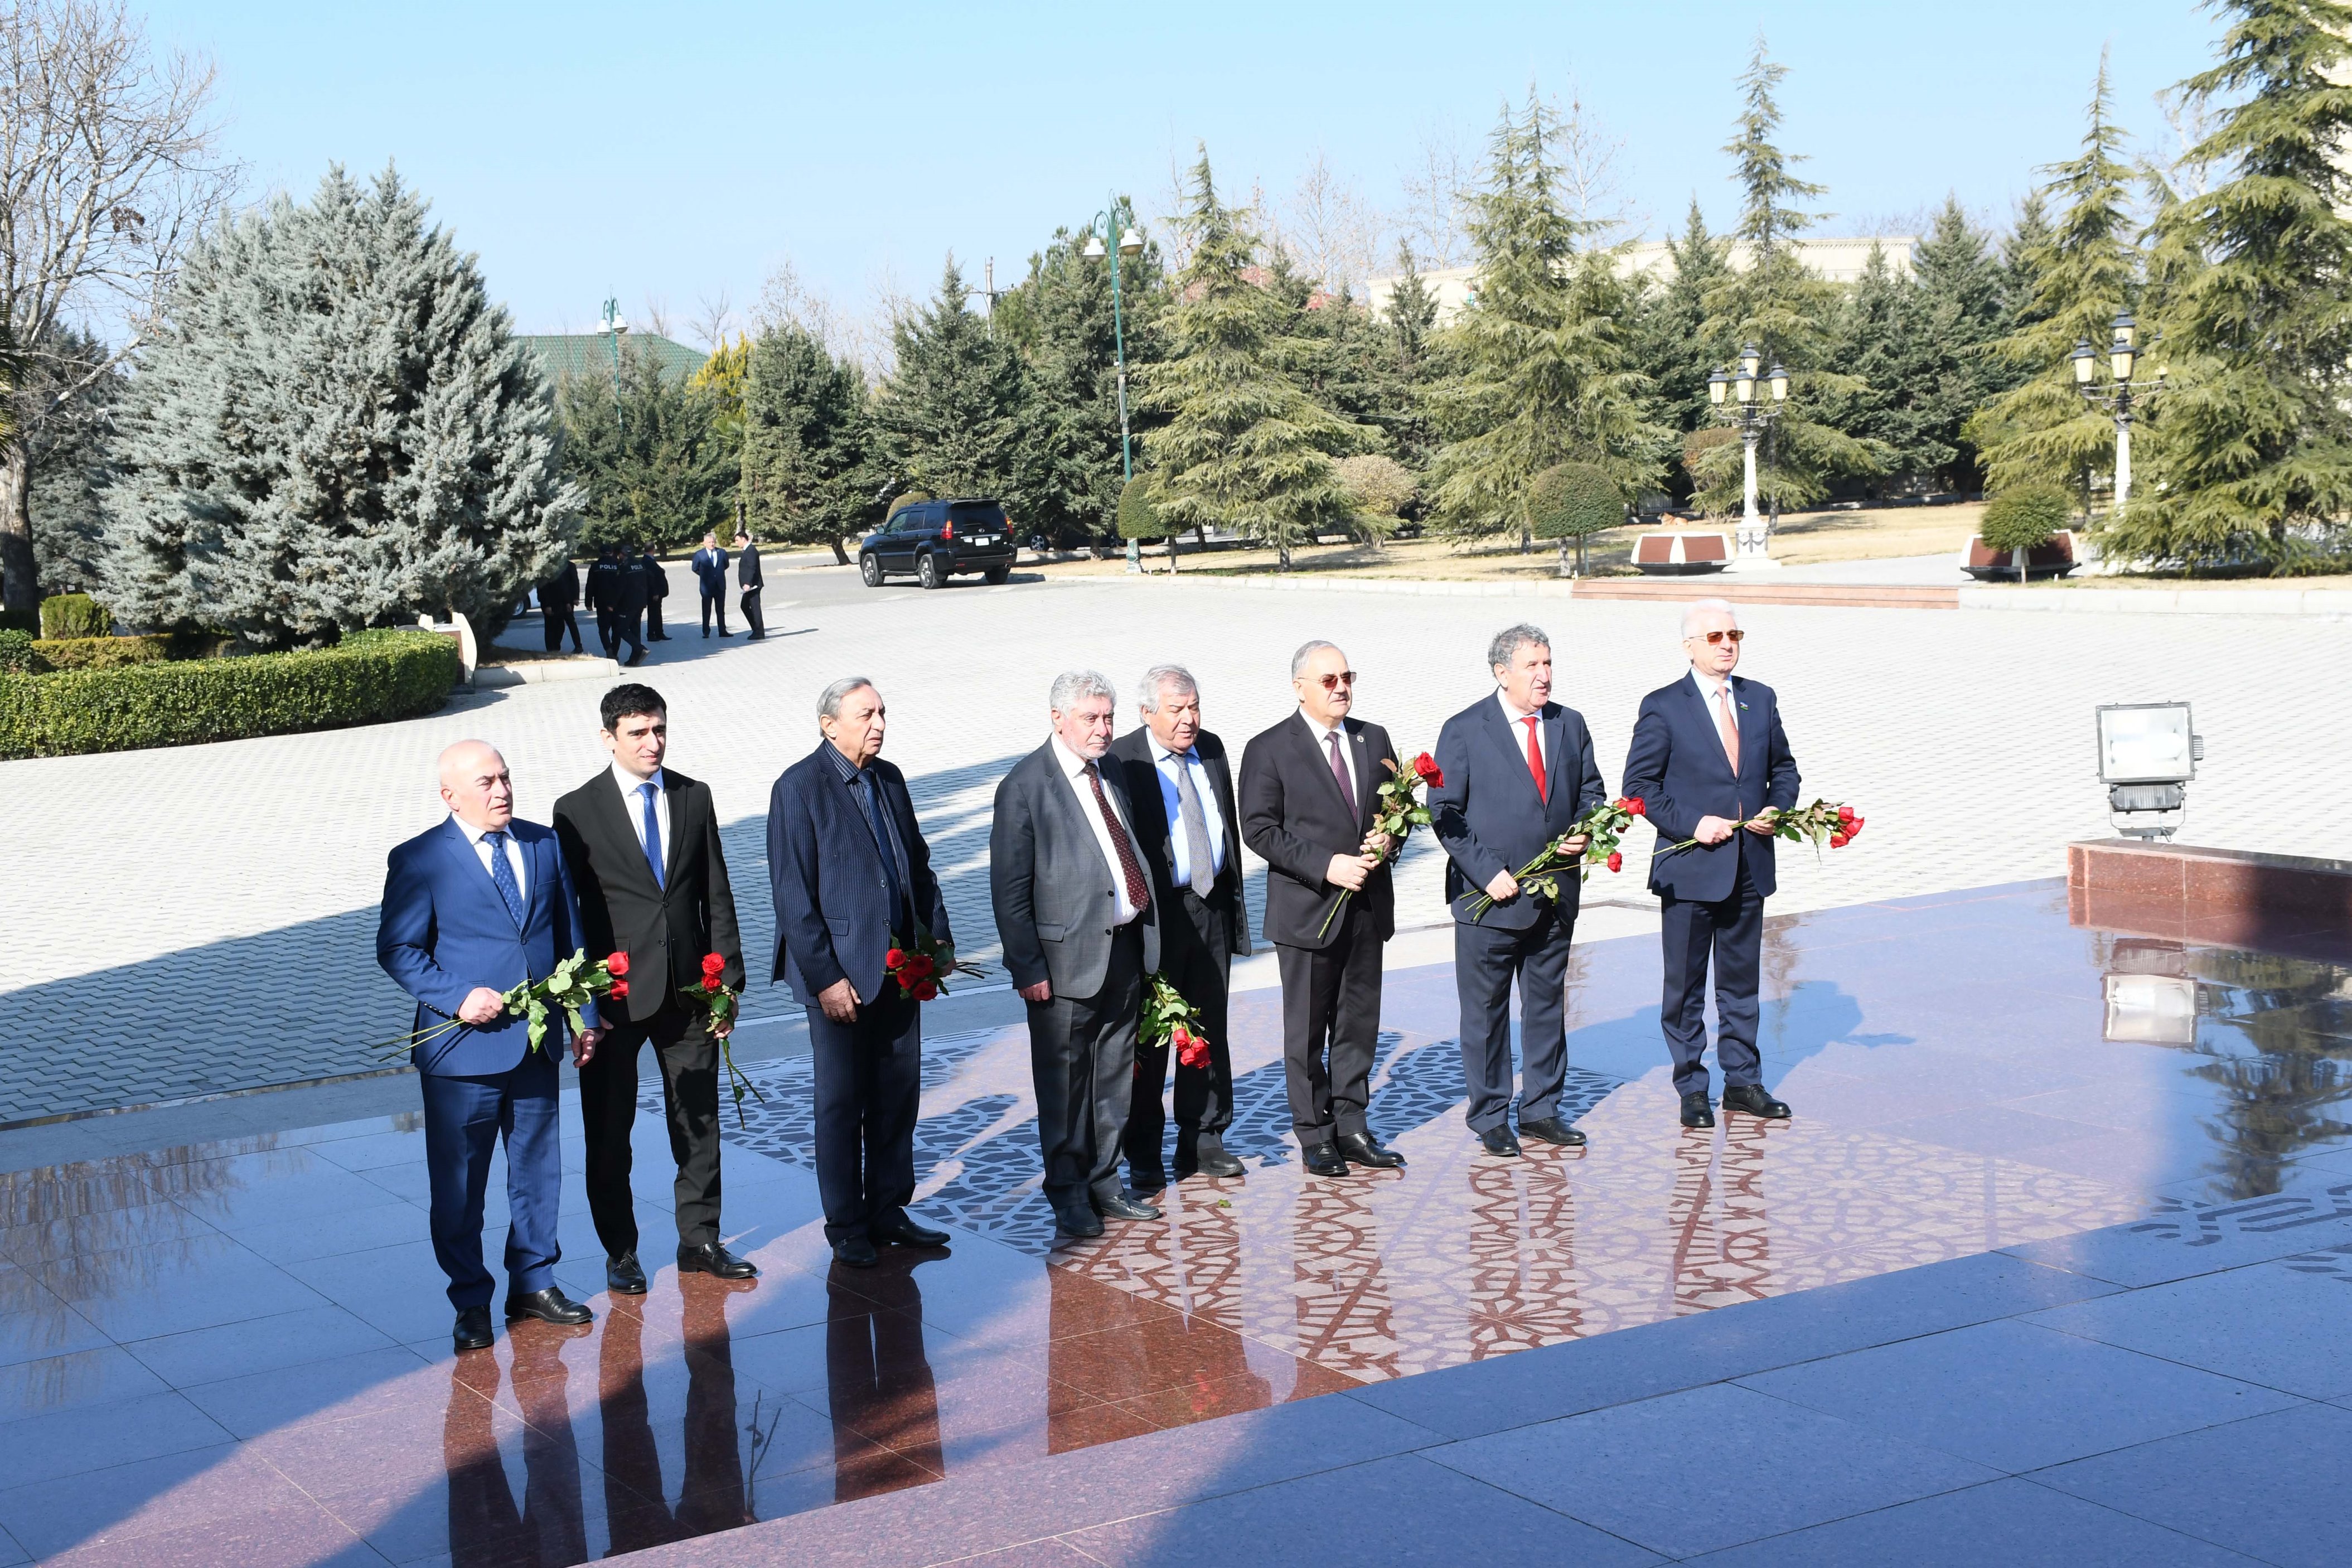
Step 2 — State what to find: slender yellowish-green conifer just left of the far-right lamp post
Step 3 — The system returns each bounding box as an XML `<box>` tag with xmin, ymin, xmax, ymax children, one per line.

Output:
<box><xmin>1968</xmin><ymin>56</ymin><xmax>2140</xmax><ymax>515</ymax></box>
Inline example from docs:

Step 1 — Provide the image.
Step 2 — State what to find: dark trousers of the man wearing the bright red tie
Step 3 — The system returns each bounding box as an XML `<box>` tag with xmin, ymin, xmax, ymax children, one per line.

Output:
<box><xmin>1454</xmin><ymin>903</ymin><xmax>1576</xmax><ymax>1133</ymax></box>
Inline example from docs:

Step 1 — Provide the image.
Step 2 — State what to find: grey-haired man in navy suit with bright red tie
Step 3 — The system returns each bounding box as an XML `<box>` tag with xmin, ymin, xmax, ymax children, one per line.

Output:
<box><xmin>1430</xmin><ymin>625</ymin><xmax>1606</xmax><ymax>1159</ymax></box>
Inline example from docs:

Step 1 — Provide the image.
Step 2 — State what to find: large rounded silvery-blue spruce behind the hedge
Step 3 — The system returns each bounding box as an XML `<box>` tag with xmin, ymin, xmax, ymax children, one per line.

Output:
<box><xmin>101</xmin><ymin>167</ymin><xmax>579</xmax><ymax>646</ymax></box>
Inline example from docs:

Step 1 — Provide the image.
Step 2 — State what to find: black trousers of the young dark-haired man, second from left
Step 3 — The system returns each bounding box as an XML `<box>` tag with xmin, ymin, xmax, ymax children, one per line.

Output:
<box><xmin>581</xmin><ymin>997</ymin><xmax>720</xmax><ymax>1255</ymax></box>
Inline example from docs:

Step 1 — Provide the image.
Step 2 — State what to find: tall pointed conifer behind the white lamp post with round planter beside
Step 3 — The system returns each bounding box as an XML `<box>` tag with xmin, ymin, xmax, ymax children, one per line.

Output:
<box><xmin>1686</xmin><ymin>35</ymin><xmax>1893</xmax><ymax>515</ymax></box>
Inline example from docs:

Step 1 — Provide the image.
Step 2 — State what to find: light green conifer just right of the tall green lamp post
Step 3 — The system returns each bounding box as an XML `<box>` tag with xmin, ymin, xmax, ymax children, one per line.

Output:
<box><xmin>1143</xmin><ymin>148</ymin><xmax>1378</xmax><ymax>571</ymax></box>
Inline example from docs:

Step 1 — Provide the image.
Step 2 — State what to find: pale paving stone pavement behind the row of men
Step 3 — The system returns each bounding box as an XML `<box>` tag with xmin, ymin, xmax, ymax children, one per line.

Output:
<box><xmin>0</xmin><ymin>578</ymin><xmax>2352</xmax><ymax>1124</ymax></box>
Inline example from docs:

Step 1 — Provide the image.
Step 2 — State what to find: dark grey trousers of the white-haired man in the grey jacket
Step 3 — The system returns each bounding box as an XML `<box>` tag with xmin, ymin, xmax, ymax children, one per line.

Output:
<box><xmin>1028</xmin><ymin>922</ymin><xmax>1143</xmax><ymax>1204</ymax></box>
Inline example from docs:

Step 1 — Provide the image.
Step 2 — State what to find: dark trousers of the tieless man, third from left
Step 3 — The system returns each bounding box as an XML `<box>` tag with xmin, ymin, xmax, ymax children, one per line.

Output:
<box><xmin>809</xmin><ymin>978</ymin><xmax>922</xmax><ymax>1241</ymax></box>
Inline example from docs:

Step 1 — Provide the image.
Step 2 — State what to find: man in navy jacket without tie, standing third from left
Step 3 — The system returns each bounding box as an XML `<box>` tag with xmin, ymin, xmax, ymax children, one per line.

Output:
<box><xmin>767</xmin><ymin>675</ymin><xmax>955</xmax><ymax>1270</ymax></box>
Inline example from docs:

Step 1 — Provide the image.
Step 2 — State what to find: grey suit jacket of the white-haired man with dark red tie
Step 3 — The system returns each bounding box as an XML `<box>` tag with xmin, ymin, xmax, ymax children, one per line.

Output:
<box><xmin>988</xmin><ymin>741</ymin><xmax>1159</xmax><ymax>997</ymax></box>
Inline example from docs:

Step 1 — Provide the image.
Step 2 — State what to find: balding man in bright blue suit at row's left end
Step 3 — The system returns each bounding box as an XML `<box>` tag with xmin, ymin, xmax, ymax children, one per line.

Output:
<box><xmin>376</xmin><ymin>741</ymin><xmax>602</xmax><ymax>1352</ymax></box>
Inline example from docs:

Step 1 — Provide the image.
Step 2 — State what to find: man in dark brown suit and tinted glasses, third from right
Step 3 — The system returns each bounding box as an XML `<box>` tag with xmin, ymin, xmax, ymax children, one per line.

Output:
<box><xmin>1242</xmin><ymin>642</ymin><xmax>1404</xmax><ymax>1175</ymax></box>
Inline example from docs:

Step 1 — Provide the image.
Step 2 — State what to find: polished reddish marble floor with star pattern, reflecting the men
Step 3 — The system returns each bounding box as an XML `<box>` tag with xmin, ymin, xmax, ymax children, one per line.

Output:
<box><xmin>0</xmin><ymin>884</ymin><xmax>2352</xmax><ymax>1566</ymax></box>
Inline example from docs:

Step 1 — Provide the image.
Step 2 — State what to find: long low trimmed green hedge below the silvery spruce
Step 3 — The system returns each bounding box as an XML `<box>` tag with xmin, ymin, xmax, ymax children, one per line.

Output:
<box><xmin>0</xmin><ymin>630</ymin><xmax>463</xmax><ymax>757</ymax></box>
